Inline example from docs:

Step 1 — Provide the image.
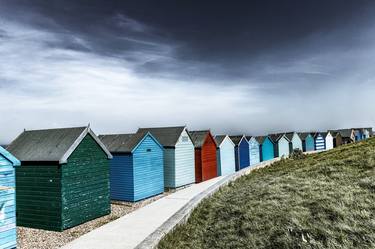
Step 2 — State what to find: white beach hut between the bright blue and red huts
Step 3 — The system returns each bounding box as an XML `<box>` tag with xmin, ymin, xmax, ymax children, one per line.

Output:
<box><xmin>138</xmin><ymin>126</ymin><xmax>195</xmax><ymax>188</ymax></box>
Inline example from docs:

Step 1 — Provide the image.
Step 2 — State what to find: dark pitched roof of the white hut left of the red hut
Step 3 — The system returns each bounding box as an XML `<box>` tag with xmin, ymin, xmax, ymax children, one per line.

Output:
<box><xmin>138</xmin><ymin>126</ymin><xmax>186</xmax><ymax>147</ymax></box>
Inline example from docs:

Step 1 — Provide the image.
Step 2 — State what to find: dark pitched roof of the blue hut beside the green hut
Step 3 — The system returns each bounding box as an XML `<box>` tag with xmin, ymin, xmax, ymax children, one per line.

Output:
<box><xmin>99</xmin><ymin>132</ymin><xmax>156</xmax><ymax>153</ymax></box>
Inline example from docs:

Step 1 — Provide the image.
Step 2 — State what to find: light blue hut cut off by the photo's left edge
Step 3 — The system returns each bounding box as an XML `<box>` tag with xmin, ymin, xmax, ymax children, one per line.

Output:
<box><xmin>0</xmin><ymin>146</ymin><xmax>21</xmax><ymax>248</ymax></box>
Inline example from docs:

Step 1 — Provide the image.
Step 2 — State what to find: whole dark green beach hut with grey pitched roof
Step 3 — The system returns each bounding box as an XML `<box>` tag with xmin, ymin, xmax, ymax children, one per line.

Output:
<box><xmin>8</xmin><ymin>127</ymin><xmax>112</xmax><ymax>231</ymax></box>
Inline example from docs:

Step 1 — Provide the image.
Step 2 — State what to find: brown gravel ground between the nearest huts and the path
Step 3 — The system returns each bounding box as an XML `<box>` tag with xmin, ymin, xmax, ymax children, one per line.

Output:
<box><xmin>17</xmin><ymin>194</ymin><xmax>167</xmax><ymax>249</ymax></box>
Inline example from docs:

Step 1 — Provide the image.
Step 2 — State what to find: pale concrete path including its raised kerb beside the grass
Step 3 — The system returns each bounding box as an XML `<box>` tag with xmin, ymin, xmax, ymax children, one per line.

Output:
<box><xmin>62</xmin><ymin>158</ymin><xmax>279</xmax><ymax>249</ymax></box>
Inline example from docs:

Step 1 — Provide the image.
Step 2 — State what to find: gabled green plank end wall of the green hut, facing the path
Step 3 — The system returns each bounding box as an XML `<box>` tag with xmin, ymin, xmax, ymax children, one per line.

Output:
<box><xmin>61</xmin><ymin>135</ymin><xmax>111</xmax><ymax>230</ymax></box>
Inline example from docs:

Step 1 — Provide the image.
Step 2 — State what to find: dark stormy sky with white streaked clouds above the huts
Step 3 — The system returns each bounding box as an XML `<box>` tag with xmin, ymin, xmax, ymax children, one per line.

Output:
<box><xmin>0</xmin><ymin>0</ymin><xmax>375</xmax><ymax>144</ymax></box>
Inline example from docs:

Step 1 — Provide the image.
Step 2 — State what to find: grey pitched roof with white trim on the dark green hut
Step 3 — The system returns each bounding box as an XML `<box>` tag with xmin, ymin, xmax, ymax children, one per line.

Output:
<box><xmin>7</xmin><ymin>127</ymin><xmax>112</xmax><ymax>164</ymax></box>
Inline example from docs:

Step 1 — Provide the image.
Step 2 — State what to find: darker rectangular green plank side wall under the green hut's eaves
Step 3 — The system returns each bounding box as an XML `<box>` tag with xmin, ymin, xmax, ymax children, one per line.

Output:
<box><xmin>16</xmin><ymin>164</ymin><xmax>62</xmax><ymax>231</ymax></box>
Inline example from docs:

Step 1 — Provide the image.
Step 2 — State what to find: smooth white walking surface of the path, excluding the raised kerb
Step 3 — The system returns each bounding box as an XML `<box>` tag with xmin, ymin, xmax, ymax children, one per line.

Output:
<box><xmin>62</xmin><ymin>177</ymin><xmax>224</xmax><ymax>249</ymax></box>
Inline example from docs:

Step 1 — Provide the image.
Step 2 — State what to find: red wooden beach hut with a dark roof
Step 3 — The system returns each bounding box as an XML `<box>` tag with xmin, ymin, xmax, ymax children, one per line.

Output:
<box><xmin>189</xmin><ymin>130</ymin><xmax>217</xmax><ymax>183</ymax></box>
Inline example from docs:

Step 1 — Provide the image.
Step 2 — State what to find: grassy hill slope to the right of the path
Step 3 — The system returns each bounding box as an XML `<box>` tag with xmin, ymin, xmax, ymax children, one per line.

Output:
<box><xmin>159</xmin><ymin>139</ymin><xmax>375</xmax><ymax>249</ymax></box>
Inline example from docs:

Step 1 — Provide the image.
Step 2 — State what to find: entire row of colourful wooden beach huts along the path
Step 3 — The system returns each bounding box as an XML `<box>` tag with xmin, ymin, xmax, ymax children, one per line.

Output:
<box><xmin>0</xmin><ymin>126</ymin><xmax>372</xmax><ymax>248</ymax></box>
